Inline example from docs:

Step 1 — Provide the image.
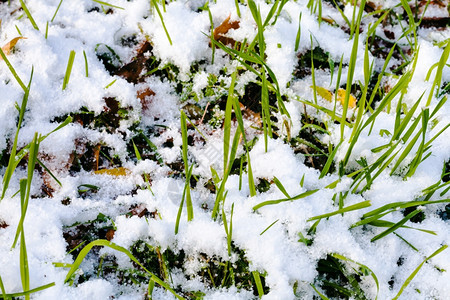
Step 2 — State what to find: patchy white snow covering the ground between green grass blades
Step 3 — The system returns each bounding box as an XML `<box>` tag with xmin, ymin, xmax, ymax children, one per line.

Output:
<box><xmin>0</xmin><ymin>0</ymin><xmax>450</xmax><ymax>300</ymax></box>
